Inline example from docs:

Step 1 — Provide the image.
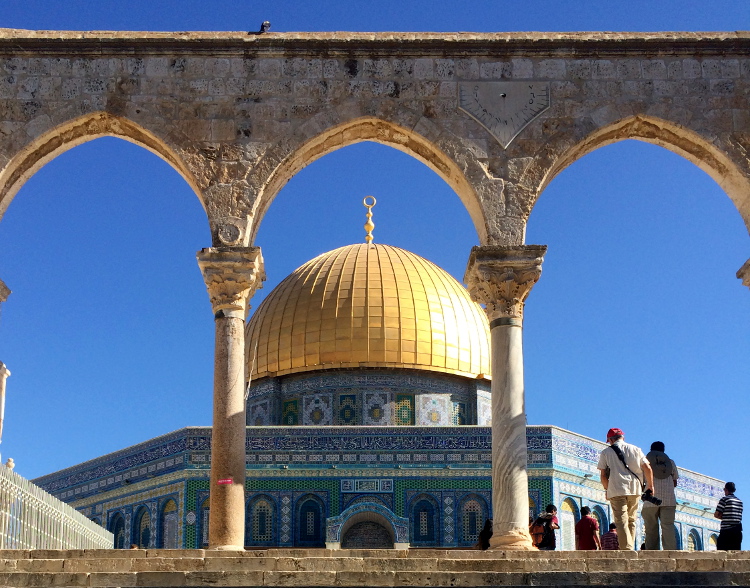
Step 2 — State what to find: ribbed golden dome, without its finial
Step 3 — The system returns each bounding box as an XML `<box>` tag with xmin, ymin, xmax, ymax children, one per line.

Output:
<box><xmin>246</xmin><ymin>243</ymin><xmax>490</xmax><ymax>379</ymax></box>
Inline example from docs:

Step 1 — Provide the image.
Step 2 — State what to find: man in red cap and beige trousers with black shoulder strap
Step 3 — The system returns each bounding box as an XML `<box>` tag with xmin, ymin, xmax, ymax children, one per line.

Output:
<box><xmin>596</xmin><ymin>428</ymin><xmax>654</xmax><ymax>550</ymax></box>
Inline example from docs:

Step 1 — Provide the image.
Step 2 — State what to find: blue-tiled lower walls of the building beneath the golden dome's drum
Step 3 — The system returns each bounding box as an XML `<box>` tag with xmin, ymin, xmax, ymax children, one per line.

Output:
<box><xmin>35</xmin><ymin>426</ymin><xmax>723</xmax><ymax>550</ymax></box>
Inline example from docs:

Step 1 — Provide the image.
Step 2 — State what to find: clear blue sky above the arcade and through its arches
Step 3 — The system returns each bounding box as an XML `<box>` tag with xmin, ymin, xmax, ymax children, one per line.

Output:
<box><xmin>0</xmin><ymin>0</ymin><xmax>750</xmax><ymax>544</ymax></box>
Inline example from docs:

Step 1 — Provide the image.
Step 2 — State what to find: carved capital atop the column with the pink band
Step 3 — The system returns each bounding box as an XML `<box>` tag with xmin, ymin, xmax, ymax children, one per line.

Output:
<box><xmin>196</xmin><ymin>247</ymin><xmax>266</xmax><ymax>320</ymax></box>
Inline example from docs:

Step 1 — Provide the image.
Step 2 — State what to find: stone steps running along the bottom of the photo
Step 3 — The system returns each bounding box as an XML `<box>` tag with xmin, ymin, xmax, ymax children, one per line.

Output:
<box><xmin>0</xmin><ymin>549</ymin><xmax>750</xmax><ymax>588</ymax></box>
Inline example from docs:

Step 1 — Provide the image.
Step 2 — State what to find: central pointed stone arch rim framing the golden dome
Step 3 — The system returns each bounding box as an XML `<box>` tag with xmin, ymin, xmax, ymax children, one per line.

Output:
<box><xmin>250</xmin><ymin>112</ymin><xmax>494</xmax><ymax>243</ymax></box>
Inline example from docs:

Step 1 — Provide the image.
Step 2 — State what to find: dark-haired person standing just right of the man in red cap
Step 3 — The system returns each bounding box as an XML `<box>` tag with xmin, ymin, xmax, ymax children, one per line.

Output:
<box><xmin>641</xmin><ymin>441</ymin><xmax>679</xmax><ymax>549</ymax></box>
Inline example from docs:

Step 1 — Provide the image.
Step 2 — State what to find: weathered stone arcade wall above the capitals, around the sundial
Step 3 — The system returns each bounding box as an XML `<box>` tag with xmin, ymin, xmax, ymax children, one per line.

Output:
<box><xmin>0</xmin><ymin>29</ymin><xmax>750</xmax><ymax>255</ymax></box>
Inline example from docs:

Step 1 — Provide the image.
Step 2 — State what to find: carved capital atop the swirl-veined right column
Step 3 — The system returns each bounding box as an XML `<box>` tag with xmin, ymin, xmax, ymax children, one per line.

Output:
<box><xmin>464</xmin><ymin>245</ymin><xmax>547</xmax><ymax>328</ymax></box>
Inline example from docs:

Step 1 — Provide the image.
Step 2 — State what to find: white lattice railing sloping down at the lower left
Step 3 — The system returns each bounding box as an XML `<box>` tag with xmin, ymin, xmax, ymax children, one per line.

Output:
<box><xmin>0</xmin><ymin>465</ymin><xmax>114</xmax><ymax>549</ymax></box>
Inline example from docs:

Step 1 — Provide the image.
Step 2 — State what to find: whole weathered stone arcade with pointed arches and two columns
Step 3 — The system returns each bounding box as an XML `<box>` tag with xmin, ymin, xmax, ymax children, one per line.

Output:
<box><xmin>0</xmin><ymin>29</ymin><xmax>750</xmax><ymax>549</ymax></box>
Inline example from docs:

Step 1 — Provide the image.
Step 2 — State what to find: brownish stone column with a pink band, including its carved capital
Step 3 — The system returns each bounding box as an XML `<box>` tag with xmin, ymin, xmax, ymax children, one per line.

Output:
<box><xmin>198</xmin><ymin>247</ymin><xmax>265</xmax><ymax>550</ymax></box>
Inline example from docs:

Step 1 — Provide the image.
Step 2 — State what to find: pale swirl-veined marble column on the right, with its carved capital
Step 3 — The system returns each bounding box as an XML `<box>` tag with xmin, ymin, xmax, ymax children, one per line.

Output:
<box><xmin>464</xmin><ymin>245</ymin><xmax>547</xmax><ymax>550</ymax></box>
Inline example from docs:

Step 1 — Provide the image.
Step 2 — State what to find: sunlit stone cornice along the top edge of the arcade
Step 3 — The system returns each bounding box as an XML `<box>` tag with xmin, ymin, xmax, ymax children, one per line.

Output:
<box><xmin>0</xmin><ymin>28</ymin><xmax>750</xmax><ymax>55</ymax></box>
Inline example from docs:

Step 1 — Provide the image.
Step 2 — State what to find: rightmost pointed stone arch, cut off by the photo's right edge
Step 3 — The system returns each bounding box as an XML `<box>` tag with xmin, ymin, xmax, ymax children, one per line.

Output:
<box><xmin>521</xmin><ymin>114</ymin><xmax>750</xmax><ymax>231</ymax></box>
